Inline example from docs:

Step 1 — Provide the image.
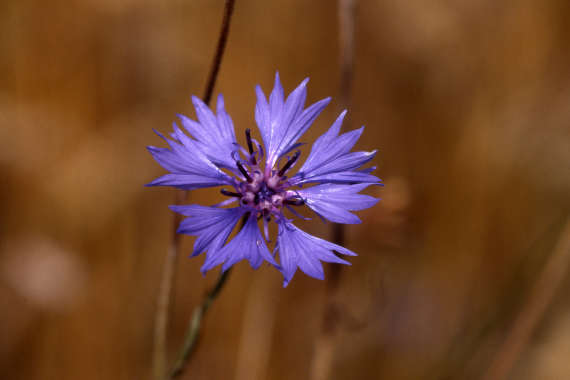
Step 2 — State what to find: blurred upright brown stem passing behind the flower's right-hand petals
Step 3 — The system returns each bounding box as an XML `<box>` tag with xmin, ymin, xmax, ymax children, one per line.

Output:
<box><xmin>311</xmin><ymin>0</ymin><xmax>356</xmax><ymax>380</ymax></box>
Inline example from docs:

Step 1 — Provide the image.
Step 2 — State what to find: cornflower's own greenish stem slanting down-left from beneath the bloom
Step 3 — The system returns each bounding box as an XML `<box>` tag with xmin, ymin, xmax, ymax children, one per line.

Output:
<box><xmin>170</xmin><ymin>268</ymin><xmax>231</xmax><ymax>379</ymax></box>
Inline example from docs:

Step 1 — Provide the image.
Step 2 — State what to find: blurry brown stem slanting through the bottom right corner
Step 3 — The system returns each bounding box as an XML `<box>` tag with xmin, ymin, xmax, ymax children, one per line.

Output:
<box><xmin>482</xmin><ymin>219</ymin><xmax>570</xmax><ymax>380</ymax></box>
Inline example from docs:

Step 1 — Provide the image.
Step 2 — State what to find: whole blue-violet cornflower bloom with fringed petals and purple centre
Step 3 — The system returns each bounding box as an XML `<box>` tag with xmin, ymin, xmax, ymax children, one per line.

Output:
<box><xmin>148</xmin><ymin>74</ymin><xmax>380</xmax><ymax>286</ymax></box>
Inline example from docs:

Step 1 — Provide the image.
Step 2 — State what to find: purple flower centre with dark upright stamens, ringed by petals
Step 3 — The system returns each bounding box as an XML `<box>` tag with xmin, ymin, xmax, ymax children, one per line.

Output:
<box><xmin>221</xmin><ymin>129</ymin><xmax>304</xmax><ymax>221</ymax></box>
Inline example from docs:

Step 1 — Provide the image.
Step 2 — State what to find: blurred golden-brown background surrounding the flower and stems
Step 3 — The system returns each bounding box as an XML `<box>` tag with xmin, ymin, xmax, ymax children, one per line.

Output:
<box><xmin>0</xmin><ymin>0</ymin><xmax>570</xmax><ymax>380</ymax></box>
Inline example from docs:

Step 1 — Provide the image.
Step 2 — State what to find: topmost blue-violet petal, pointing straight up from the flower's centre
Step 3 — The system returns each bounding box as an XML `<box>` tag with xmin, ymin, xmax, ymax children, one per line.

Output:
<box><xmin>255</xmin><ymin>73</ymin><xmax>330</xmax><ymax>166</ymax></box>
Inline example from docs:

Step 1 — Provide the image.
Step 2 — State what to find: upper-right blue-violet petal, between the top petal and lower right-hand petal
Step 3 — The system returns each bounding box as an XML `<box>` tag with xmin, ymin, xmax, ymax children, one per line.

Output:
<box><xmin>290</xmin><ymin>111</ymin><xmax>379</xmax><ymax>185</ymax></box>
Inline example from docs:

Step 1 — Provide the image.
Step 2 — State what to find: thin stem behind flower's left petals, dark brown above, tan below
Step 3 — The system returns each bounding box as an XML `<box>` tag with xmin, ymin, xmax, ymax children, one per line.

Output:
<box><xmin>153</xmin><ymin>0</ymin><xmax>235</xmax><ymax>380</ymax></box>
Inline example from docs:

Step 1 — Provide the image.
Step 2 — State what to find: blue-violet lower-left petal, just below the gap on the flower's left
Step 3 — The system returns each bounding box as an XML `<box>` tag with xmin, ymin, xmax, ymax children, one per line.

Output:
<box><xmin>166</xmin><ymin>205</ymin><xmax>245</xmax><ymax>268</ymax></box>
